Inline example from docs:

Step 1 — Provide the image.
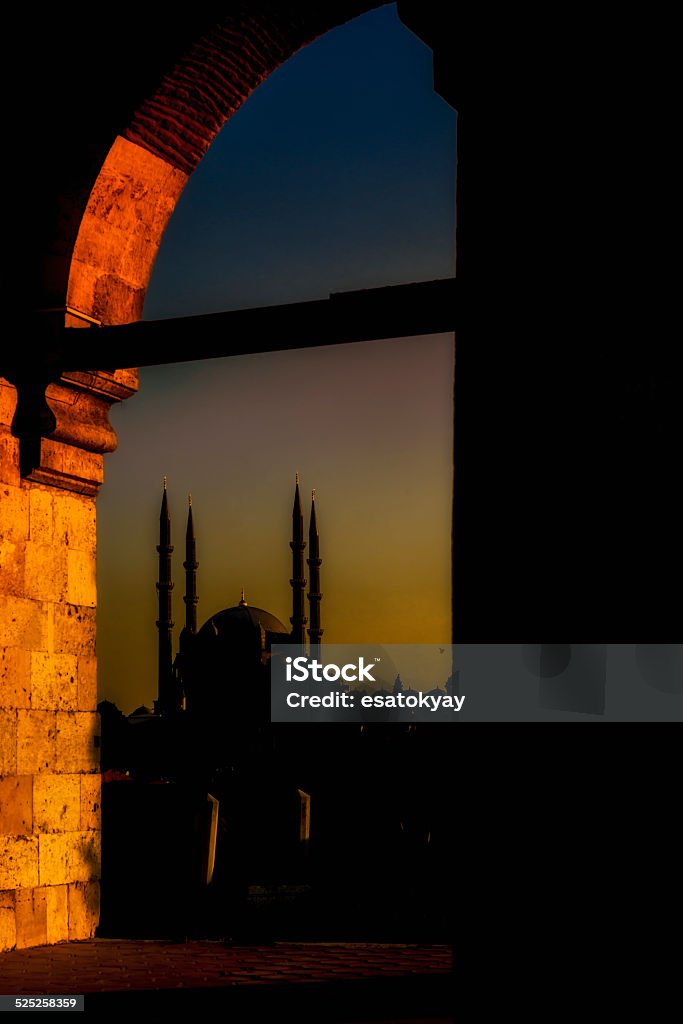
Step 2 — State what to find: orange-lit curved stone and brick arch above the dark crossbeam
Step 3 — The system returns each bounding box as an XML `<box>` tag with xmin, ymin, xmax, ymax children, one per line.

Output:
<box><xmin>66</xmin><ymin>0</ymin><xmax>383</xmax><ymax>326</ymax></box>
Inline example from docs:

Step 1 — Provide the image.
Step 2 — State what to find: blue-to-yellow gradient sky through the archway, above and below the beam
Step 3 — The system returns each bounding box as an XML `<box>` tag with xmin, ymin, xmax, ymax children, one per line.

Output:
<box><xmin>97</xmin><ymin>5</ymin><xmax>455</xmax><ymax>712</ymax></box>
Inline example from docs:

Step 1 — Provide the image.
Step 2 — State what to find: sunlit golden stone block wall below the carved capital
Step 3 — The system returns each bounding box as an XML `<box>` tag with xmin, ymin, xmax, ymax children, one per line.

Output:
<box><xmin>0</xmin><ymin>380</ymin><xmax>108</xmax><ymax>949</ymax></box>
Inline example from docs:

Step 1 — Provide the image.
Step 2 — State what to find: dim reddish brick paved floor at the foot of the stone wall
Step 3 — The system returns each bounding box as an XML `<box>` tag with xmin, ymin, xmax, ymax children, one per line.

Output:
<box><xmin>0</xmin><ymin>939</ymin><xmax>452</xmax><ymax>1024</ymax></box>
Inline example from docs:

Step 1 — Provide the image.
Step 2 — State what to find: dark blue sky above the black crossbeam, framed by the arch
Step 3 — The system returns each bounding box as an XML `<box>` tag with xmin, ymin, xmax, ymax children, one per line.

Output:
<box><xmin>144</xmin><ymin>4</ymin><xmax>456</xmax><ymax>318</ymax></box>
